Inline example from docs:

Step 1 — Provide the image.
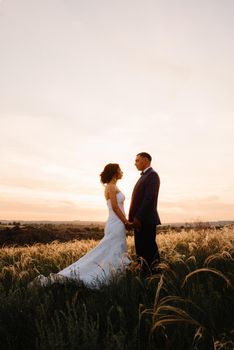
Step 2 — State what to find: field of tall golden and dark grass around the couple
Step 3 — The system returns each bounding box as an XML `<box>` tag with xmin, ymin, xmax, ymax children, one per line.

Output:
<box><xmin>0</xmin><ymin>226</ymin><xmax>234</xmax><ymax>350</ymax></box>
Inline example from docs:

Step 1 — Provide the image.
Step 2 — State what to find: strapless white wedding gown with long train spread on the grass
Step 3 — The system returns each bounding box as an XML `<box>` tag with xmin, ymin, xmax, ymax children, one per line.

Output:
<box><xmin>32</xmin><ymin>192</ymin><xmax>130</xmax><ymax>288</ymax></box>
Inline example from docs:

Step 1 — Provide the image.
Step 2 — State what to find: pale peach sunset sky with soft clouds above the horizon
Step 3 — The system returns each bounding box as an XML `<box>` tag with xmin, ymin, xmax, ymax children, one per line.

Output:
<box><xmin>0</xmin><ymin>0</ymin><xmax>234</xmax><ymax>223</ymax></box>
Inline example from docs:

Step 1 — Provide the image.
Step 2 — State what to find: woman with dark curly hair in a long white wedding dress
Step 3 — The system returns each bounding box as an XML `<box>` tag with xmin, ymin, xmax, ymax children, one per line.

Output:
<box><xmin>31</xmin><ymin>163</ymin><xmax>131</xmax><ymax>287</ymax></box>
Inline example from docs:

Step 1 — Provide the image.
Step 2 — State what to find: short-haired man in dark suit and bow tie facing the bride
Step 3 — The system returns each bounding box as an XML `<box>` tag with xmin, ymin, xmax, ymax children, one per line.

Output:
<box><xmin>126</xmin><ymin>152</ymin><xmax>161</xmax><ymax>271</ymax></box>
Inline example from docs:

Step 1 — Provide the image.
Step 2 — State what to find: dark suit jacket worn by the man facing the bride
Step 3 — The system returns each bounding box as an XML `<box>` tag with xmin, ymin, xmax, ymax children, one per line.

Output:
<box><xmin>129</xmin><ymin>168</ymin><xmax>161</xmax><ymax>225</ymax></box>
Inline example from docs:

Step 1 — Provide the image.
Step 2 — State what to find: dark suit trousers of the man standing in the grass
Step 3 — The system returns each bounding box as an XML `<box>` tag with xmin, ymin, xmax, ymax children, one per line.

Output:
<box><xmin>134</xmin><ymin>223</ymin><xmax>160</xmax><ymax>268</ymax></box>
